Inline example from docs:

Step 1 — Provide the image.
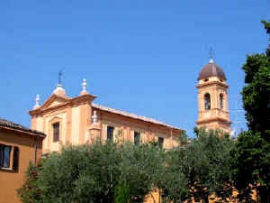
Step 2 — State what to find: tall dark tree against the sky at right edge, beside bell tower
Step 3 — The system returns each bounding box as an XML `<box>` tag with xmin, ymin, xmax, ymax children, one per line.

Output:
<box><xmin>242</xmin><ymin>22</ymin><xmax>270</xmax><ymax>139</ymax></box>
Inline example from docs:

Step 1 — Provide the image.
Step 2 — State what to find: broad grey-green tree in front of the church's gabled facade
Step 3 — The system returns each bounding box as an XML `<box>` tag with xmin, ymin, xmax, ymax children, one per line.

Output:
<box><xmin>35</xmin><ymin>142</ymin><xmax>119</xmax><ymax>203</ymax></box>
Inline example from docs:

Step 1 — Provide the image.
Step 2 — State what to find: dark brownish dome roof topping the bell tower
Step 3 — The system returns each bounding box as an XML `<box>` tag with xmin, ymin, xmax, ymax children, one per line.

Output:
<box><xmin>198</xmin><ymin>59</ymin><xmax>226</xmax><ymax>80</ymax></box>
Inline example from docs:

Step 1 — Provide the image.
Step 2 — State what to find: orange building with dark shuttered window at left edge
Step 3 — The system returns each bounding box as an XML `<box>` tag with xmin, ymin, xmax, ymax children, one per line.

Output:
<box><xmin>0</xmin><ymin>119</ymin><xmax>45</xmax><ymax>203</ymax></box>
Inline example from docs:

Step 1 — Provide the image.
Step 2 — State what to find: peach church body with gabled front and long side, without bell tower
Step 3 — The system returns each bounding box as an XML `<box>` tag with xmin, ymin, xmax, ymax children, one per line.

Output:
<box><xmin>29</xmin><ymin>79</ymin><xmax>184</xmax><ymax>154</ymax></box>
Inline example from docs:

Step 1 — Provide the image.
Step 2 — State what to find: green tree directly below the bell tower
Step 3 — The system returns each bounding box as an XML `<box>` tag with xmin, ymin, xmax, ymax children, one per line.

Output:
<box><xmin>186</xmin><ymin>129</ymin><xmax>234</xmax><ymax>202</ymax></box>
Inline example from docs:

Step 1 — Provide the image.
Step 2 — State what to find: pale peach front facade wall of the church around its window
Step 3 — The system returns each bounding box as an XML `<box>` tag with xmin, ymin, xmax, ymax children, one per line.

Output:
<box><xmin>32</xmin><ymin>102</ymin><xmax>92</xmax><ymax>153</ymax></box>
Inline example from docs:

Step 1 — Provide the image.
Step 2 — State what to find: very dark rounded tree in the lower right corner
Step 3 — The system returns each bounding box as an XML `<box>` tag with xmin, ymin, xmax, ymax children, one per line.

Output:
<box><xmin>232</xmin><ymin>131</ymin><xmax>270</xmax><ymax>202</ymax></box>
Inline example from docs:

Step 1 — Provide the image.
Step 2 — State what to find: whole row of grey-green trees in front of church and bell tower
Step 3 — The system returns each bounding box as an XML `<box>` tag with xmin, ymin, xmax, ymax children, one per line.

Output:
<box><xmin>20</xmin><ymin>131</ymin><xmax>235</xmax><ymax>203</ymax></box>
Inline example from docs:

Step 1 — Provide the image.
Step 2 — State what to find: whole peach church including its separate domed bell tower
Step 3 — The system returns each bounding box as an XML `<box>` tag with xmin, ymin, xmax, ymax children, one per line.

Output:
<box><xmin>29</xmin><ymin>59</ymin><xmax>231</xmax><ymax>154</ymax></box>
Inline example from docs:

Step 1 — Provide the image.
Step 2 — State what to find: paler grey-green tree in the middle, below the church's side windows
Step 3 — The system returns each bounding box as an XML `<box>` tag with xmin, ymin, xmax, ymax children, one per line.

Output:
<box><xmin>115</xmin><ymin>143</ymin><xmax>163</xmax><ymax>203</ymax></box>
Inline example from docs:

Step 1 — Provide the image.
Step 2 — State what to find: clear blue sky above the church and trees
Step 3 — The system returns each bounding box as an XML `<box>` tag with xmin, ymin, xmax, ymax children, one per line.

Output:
<box><xmin>0</xmin><ymin>0</ymin><xmax>270</xmax><ymax>136</ymax></box>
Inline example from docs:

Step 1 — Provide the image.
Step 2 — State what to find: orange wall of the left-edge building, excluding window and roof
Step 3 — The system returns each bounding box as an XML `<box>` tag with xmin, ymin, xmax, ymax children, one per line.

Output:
<box><xmin>0</xmin><ymin>130</ymin><xmax>42</xmax><ymax>203</ymax></box>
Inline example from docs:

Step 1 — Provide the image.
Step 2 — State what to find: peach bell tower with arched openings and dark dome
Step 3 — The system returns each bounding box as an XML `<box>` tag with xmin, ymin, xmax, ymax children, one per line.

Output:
<box><xmin>197</xmin><ymin>58</ymin><xmax>231</xmax><ymax>133</ymax></box>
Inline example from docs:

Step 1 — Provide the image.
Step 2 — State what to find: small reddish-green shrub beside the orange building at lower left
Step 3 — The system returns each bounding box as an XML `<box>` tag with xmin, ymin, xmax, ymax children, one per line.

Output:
<box><xmin>17</xmin><ymin>162</ymin><xmax>41</xmax><ymax>203</ymax></box>
